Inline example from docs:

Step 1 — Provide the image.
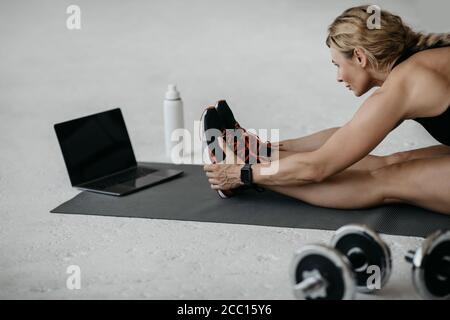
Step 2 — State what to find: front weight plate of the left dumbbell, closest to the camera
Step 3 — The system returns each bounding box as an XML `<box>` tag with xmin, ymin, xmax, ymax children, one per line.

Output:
<box><xmin>291</xmin><ymin>244</ymin><xmax>356</xmax><ymax>300</ymax></box>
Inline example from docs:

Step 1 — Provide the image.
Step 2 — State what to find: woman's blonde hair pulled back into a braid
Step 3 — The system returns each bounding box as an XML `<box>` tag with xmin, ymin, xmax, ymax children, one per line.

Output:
<box><xmin>326</xmin><ymin>6</ymin><xmax>450</xmax><ymax>70</ymax></box>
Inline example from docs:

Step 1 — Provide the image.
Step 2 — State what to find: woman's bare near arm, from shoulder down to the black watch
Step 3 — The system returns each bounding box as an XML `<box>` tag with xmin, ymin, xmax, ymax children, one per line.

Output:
<box><xmin>253</xmin><ymin>82</ymin><xmax>409</xmax><ymax>185</ymax></box>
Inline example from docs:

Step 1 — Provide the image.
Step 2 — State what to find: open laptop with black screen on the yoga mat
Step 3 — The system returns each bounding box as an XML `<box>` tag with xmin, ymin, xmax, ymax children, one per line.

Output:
<box><xmin>54</xmin><ymin>108</ymin><xmax>183</xmax><ymax>196</ymax></box>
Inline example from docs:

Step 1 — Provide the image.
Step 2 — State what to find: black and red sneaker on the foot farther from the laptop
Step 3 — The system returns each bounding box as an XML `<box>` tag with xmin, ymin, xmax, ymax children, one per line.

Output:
<box><xmin>216</xmin><ymin>100</ymin><xmax>272</xmax><ymax>163</ymax></box>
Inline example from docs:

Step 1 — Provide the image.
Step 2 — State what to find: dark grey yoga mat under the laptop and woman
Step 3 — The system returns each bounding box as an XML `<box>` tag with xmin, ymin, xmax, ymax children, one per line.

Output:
<box><xmin>51</xmin><ymin>163</ymin><xmax>450</xmax><ymax>237</ymax></box>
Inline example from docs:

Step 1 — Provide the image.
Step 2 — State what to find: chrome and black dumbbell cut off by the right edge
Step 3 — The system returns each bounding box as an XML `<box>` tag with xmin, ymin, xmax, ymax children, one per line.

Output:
<box><xmin>405</xmin><ymin>230</ymin><xmax>450</xmax><ymax>300</ymax></box>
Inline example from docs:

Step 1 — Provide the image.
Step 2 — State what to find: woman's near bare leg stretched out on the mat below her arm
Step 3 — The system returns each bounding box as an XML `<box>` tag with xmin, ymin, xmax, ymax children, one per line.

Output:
<box><xmin>268</xmin><ymin>156</ymin><xmax>450</xmax><ymax>214</ymax></box>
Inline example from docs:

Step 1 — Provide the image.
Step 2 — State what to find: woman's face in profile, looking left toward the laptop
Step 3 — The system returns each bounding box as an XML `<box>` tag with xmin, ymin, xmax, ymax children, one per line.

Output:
<box><xmin>330</xmin><ymin>47</ymin><xmax>372</xmax><ymax>97</ymax></box>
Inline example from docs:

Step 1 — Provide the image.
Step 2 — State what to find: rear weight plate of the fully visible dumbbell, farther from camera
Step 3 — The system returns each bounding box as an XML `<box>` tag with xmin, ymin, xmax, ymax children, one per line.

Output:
<box><xmin>331</xmin><ymin>224</ymin><xmax>392</xmax><ymax>293</ymax></box>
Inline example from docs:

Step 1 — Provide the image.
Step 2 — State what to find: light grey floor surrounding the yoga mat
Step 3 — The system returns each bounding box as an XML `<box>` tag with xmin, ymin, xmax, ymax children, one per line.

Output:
<box><xmin>0</xmin><ymin>0</ymin><xmax>449</xmax><ymax>299</ymax></box>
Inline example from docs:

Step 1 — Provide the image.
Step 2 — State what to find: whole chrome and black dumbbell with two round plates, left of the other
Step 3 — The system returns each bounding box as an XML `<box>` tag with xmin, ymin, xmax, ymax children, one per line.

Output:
<box><xmin>291</xmin><ymin>224</ymin><xmax>392</xmax><ymax>300</ymax></box>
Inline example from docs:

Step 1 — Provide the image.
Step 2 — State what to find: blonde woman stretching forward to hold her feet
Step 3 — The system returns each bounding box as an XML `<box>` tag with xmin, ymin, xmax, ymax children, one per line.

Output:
<box><xmin>204</xmin><ymin>6</ymin><xmax>450</xmax><ymax>214</ymax></box>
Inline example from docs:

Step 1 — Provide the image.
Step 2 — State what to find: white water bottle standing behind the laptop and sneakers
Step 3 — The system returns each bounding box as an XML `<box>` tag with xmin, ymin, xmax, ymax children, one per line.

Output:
<box><xmin>164</xmin><ymin>84</ymin><xmax>184</xmax><ymax>158</ymax></box>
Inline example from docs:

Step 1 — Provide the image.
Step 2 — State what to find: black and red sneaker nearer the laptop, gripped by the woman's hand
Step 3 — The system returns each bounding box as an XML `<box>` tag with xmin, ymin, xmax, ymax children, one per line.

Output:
<box><xmin>203</xmin><ymin>106</ymin><xmax>233</xmax><ymax>198</ymax></box>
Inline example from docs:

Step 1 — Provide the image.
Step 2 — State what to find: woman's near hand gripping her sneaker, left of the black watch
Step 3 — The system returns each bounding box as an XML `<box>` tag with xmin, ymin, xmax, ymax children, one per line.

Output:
<box><xmin>203</xmin><ymin>164</ymin><xmax>243</xmax><ymax>190</ymax></box>
